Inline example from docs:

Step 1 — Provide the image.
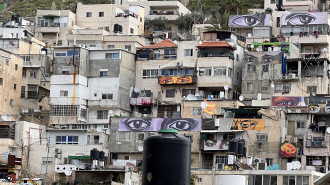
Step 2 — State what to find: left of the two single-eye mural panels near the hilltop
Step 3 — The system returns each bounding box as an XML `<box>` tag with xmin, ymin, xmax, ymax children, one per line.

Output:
<box><xmin>228</xmin><ymin>14</ymin><xmax>271</xmax><ymax>27</ymax></box>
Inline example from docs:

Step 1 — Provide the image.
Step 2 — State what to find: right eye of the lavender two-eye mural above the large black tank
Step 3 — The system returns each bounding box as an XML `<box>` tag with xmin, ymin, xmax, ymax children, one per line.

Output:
<box><xmin>162</xmin><ymin>119</ymin><xmax>197</xmax><ymax>131</ymax></box>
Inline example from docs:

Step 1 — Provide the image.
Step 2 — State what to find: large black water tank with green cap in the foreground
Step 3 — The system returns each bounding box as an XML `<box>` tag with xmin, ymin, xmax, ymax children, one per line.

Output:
<box><xmin>142</xmin><ymin>129</ymin><xmax>191</xmax><ymax>185</ymax></box>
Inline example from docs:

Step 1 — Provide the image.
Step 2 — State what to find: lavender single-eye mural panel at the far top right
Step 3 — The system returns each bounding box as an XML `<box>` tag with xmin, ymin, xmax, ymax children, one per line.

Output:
<box><xmin>282</xmin><ymin>12</ymin><xmax>328</xmax><ymax>25</ymax></box>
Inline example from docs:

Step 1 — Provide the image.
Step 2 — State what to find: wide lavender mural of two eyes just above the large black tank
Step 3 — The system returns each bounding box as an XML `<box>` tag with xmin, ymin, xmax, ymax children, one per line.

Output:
<box><xmin>119</xmin><ymin>118</ymin><xmax>202</xmax><ymax>132</ymax></box>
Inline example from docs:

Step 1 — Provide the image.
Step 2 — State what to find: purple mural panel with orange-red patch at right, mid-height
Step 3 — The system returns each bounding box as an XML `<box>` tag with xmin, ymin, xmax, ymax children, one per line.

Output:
<box><xmin>272</xmin><ymin>96</ymin><xmax>306</xmax><ymax>107</ymax></box>
